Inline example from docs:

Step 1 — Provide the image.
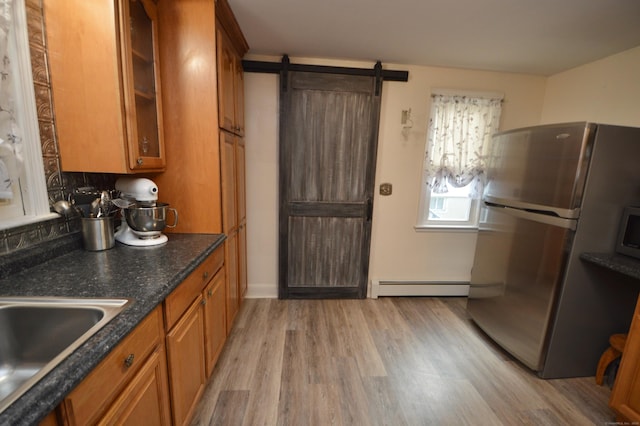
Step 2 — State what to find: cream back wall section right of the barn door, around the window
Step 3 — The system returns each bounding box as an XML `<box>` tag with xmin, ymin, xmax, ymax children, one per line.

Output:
<box><xmin>369</xmin><ymin>65</ymin><xmax>546</xmax><ymax>290</ymax></box>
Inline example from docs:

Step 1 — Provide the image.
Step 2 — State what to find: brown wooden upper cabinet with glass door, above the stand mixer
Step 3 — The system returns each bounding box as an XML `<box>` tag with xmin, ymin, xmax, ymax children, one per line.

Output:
<box><xmin>44</xmin><ymin>0</ymin><xmax>166</xmax><ymax>173</ymax></box>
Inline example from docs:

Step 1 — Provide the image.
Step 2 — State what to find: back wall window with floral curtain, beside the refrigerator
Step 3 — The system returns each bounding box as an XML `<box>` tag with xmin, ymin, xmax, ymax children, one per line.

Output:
<box><xmin>417</xmin><ymin>93</ymin><xmax>502</xmax><ymax>228</ymax></box>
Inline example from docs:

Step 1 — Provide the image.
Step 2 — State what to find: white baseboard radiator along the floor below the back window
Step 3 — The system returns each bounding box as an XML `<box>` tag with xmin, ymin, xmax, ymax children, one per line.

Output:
<box><xmin>369</xmin><ymin>280</ymin><xmax>469</xmax><ymax>299</ymax></box>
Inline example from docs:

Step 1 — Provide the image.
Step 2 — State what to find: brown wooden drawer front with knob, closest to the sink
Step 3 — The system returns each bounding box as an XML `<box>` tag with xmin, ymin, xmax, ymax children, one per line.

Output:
<box><xmin>63</xmin><ymin>307</ymin><xmax>164</xmax><ymax>425</ymax></box>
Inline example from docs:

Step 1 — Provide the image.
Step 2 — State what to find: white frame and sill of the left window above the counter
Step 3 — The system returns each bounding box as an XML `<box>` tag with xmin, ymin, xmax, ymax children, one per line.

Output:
<box><xmin>0</xmin><ymin>0</ymin><xmax>53</xmax><ymax>230</ymax></box>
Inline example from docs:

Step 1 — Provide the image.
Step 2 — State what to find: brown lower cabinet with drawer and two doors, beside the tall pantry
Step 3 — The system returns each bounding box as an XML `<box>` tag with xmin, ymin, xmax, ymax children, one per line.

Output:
<box><xmin>164</xmin><ymin>249</ymin><xmax>227</xmax><ymax>425</ymax></box>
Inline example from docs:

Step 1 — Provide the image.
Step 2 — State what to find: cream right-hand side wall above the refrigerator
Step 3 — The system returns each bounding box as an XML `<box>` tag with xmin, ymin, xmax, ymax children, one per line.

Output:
<box><xmin>541</xmin><ymin>47</ymin><xmax>640</xmax><ymax>127</ymax></box>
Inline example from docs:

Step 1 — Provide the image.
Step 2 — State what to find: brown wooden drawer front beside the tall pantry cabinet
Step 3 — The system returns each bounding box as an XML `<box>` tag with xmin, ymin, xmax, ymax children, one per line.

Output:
<box><xmin>164</xmin><ymin>248</ymin><xmax>224</xmax><ymax>331</ymax></box>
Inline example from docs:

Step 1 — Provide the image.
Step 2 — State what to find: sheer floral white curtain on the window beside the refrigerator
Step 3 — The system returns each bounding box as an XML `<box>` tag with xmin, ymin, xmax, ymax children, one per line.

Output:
<box><xmin>424</xmin><ymin>94</ymin><xmax>502</xmax><ymax>198</ymax></box>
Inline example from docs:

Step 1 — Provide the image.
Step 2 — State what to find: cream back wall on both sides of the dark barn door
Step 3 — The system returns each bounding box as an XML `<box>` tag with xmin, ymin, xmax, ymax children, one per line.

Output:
<box><xmin>245</xmin><ymin>57</ymin><xmax>546</xmax><ymax>297</ymax></box>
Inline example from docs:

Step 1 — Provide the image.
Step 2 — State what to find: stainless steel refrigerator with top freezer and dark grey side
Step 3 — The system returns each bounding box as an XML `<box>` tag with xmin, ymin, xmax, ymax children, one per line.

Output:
<box><xmin>467</xmin><ymin>123</ymin><xmax>640</xmax><ymax>378</ymax></box>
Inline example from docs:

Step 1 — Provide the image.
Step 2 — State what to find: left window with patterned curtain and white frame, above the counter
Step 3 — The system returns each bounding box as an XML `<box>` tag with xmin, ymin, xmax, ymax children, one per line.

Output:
<box><xmin>0</xmin><ymin>0</ymin><xmax>52</xmax><ymax>229</ymax></box>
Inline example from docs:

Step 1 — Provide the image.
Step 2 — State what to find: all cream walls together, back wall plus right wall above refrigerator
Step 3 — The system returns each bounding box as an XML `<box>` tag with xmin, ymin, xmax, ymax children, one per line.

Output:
<box><xmin>245</xmin><ymin>47</ymin><xmax>640</xmax><ymax>297</ymax></box>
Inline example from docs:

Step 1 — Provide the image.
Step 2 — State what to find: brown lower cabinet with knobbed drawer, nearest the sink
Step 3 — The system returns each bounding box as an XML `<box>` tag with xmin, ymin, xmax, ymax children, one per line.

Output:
<box><xmin>60</xmin><ymin>307</ymin><xmax>171</xmax><ymax>425</ymax></box>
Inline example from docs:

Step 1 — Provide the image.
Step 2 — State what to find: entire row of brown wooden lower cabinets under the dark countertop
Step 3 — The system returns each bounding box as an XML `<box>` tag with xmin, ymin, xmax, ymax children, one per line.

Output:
<box><xmin>40</xmin><ymin>247</ymin><xmax>227</xmax><ymax>426</ymax></box>
